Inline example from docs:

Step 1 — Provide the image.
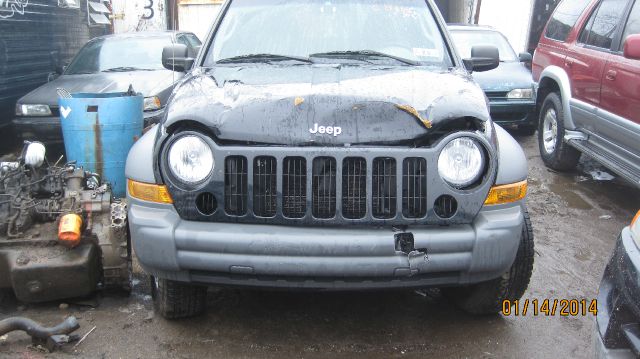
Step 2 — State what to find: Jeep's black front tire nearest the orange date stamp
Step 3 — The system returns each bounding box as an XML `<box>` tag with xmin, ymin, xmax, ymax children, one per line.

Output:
<box><xmin>442</xmin><ymin>210</ymin><xmax>534</xmax><ymax>315</ymax></box>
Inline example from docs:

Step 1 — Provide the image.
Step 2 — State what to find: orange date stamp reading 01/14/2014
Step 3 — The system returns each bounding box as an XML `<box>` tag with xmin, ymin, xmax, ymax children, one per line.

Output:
<box><xmin>502</xmin><ymin>299</ymin><xmax>598</xmax><ymax>317</ymax></box>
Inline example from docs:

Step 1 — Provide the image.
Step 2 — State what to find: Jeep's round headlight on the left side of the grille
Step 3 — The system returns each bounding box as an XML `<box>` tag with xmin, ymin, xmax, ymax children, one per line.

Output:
<box><xmin>169</xmin><ymin>135</ymin><xmax>214</xmax><ymax>184</ymax></box>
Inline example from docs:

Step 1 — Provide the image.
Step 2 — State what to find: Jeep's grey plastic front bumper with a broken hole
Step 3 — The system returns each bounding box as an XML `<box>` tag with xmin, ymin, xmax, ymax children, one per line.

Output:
<box><xmin>128</xmin><ymin>197</ymin><xmax>524</xmax><ymax>290</ymax></box>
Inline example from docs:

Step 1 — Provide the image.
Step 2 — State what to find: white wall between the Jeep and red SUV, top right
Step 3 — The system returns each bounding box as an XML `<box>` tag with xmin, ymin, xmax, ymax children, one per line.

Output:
<box><xmin>479</xmin><ymin>0</ymin><xmax>533</xmax><ymax>52</ymax></box>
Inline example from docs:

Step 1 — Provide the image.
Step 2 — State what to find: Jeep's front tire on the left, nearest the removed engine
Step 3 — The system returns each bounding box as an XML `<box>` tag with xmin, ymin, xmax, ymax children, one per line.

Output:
<box><xmin>151</xmin><ymin>277</ymin><xmax>207</xmax><ymax>319</ymax></box>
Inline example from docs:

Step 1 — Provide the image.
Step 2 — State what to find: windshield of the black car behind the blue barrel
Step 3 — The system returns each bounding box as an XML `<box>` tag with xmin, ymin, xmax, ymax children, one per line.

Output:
<box><xmin>65</xmin><ymin>36</ymin><xmax>171</xmax><ymax>75</ymax></box>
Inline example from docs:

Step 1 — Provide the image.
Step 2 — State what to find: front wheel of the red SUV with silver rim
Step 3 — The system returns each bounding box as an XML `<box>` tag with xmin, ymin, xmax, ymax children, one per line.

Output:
<box><xmin>538</xmin><ymin>92</ymin><xmax>580</xmax><ymax>171</ymax></box>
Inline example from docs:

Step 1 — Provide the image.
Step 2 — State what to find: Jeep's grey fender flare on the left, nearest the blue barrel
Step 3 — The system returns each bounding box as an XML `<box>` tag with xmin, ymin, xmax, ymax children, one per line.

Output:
<box><xmin>124</xmin><ymin>125</ymin><xmax>158</xmax><ymax>183</ymax></box>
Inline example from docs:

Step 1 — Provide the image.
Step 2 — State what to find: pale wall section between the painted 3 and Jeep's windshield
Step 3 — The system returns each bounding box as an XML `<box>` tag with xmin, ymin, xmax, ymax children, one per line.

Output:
<box><xmin>178</xmin><ymin>0</ymin><xmax>221</xmax><ymax>41</ymax></box>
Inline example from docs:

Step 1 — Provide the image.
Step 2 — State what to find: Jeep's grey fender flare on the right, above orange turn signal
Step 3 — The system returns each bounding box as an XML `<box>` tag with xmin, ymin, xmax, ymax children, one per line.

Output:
<box><xmin>494</xmin><ymin>124</ymin><xmax>529</xmax><ymax>185</ymax></box>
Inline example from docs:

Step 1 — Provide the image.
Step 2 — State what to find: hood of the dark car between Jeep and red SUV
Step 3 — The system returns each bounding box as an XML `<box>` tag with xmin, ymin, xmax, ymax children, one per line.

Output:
<box><xmin>473</xmin><ymin>62</ymin><xmax>533</xmax><ymax>92</ymax></box>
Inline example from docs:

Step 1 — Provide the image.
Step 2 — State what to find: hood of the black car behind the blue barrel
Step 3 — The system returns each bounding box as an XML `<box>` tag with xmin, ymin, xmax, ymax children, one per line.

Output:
<box><xmin>18</xmin><ymin>70</ymin><xmax>179</xmax><ymax>106</ymax></box>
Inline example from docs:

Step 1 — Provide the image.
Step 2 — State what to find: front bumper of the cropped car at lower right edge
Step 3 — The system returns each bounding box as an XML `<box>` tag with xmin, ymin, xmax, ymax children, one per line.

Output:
<box><xmin>594</xmin><ymin>228</ymin><xmax>640</xmax><ymax>358</ymax></box>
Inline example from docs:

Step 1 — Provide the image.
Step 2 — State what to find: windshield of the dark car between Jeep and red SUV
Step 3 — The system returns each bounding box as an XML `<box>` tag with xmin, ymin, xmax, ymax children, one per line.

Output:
<box><xmin>451</xmin><ymin>30</ymin><xmax>518</xmax><ymax>62</ymax></box>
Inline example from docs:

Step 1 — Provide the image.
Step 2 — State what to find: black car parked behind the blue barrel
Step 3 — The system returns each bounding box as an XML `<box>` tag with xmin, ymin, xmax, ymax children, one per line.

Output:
<box><xmin>13</xmin><ymin>31</ymin><xmax>200</xmax><ymax>142</ymax></box>
